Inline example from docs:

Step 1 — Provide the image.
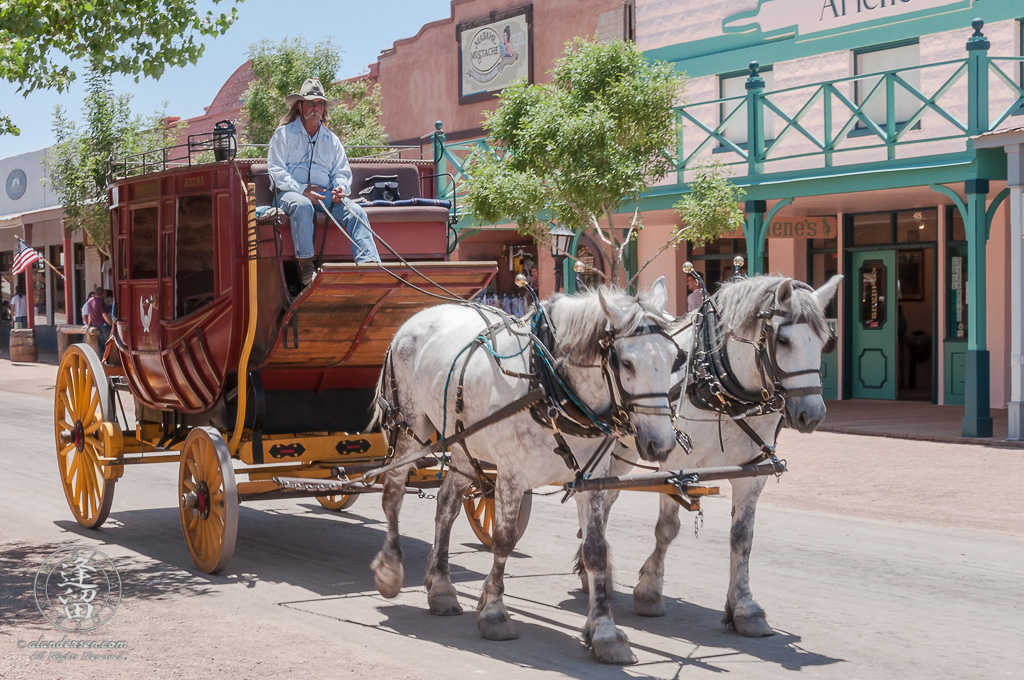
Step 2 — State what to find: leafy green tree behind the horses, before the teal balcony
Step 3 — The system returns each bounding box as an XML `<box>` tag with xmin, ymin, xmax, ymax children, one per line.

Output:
<box><xmin>466</xmin><ymin>38</ymin><xmax>741</xmax><ymax>284</ymax></box>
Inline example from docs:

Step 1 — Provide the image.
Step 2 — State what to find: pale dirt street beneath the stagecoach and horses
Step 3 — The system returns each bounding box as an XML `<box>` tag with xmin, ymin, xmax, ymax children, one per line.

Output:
<box><xmin>0</xmin><ymin>362</ymin><xmax>1024</xmax><ymax>680</ymax></box>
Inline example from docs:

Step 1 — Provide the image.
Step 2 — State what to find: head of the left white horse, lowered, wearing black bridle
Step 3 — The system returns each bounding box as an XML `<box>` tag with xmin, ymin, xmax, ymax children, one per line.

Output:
<box><xmin>549</xmin><ymin>277</ymin><xmax>677</xmax><ymax>462</ymax></box>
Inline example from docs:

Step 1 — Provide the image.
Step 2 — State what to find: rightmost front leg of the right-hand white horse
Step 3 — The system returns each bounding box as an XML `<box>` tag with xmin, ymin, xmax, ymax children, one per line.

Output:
<box><xmin>722</xmin><ymin>477</ymin><xmax>775</xmax><ymax>637</ymax></box>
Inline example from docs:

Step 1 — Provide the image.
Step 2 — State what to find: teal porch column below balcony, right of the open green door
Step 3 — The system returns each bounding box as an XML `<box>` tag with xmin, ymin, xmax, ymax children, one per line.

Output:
<box><xmin>961</xmin><ymin>179</ymin><xmax>992</xmax><ymax>437</ymax></box>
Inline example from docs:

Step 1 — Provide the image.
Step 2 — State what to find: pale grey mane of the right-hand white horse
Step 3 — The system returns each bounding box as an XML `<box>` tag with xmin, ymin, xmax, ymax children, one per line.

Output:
<box><xmin>714</xmin><ymin>274</ymin><xmax>828</xmax><ymax>339</ymax></box>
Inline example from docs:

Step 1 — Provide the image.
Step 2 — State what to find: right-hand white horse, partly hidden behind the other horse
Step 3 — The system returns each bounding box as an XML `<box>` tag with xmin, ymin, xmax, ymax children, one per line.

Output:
<box><xmin>584</xmin><ymin>275</ymin><xmax>842</xmax><ymax>637</ymax></box>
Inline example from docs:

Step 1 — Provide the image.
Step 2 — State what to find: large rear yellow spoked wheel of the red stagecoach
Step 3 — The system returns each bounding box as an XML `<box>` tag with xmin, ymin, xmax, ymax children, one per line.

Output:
<box><xmin>53</xmin><ymin>344</ymin><xmax>115</xmax><ymax>528</ymax></box>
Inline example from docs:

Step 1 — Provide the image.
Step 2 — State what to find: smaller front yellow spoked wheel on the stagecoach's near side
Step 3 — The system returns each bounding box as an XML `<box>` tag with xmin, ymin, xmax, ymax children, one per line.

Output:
<box><xmin>178</xmin><ymin>427</ymin><xmax>239</xmax><ymax>573</ymax></box>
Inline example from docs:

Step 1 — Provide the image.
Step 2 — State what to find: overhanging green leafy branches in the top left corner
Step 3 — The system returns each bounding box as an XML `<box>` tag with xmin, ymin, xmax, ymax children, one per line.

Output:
<box><xmin>0</xmin><ymin>0</ymin><xmax>242</xmax><ymax>135</ymax></box>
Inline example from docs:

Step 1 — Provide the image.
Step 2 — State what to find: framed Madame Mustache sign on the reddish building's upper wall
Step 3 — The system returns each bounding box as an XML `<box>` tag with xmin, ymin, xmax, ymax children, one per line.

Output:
<box><xmin>456</xmin><ymin>5</ymin><xmax>534</xmax><ymax>103</ymax></box>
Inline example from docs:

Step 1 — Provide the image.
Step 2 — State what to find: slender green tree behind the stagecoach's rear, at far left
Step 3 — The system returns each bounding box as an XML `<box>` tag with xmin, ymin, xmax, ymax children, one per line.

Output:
<box><xmin>46</xmin><ymin>73</ymin><xmax>165</xmax><ymax>255</ymax></box>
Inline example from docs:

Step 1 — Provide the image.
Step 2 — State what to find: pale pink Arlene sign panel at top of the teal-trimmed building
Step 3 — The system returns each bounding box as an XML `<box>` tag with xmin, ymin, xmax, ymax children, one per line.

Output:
<box><xmin>722</xmin><ymin>0</ymin><xmax>972</xmax><ymax>36</ymax></box>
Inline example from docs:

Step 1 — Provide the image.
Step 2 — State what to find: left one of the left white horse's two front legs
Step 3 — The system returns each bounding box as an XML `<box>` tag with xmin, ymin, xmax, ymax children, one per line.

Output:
<box><xmin>476</xmin><ymin>475</ymin><xmax>526</xmax><ymax>640</ymax></box>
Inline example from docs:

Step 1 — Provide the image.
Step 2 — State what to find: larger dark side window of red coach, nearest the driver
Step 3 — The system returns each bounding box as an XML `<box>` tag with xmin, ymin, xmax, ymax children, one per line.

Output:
<box><xmin>174</xmin><ymin>196</ymin><xmax>214</xmax><ymax>316</ymax></box>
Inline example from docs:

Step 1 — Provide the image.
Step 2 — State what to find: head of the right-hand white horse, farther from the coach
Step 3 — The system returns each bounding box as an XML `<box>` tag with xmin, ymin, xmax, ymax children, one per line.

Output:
<box><xmin>716</xmin><ymin>274</ymin><xmax>843</xmax><ymax>432</ymax></box>
